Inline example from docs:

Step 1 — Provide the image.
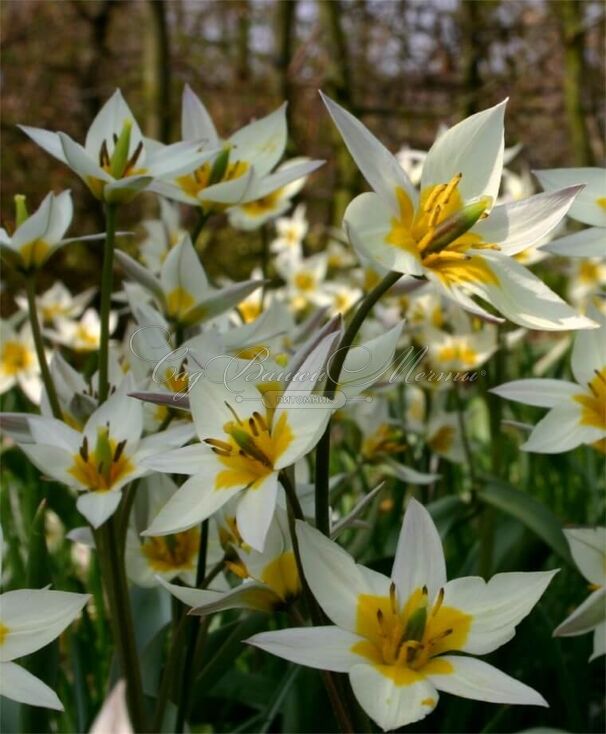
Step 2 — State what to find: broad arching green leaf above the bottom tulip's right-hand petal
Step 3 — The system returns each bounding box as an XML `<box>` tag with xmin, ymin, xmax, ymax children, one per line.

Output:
<box><xmin>478</xmin><ymin>480</ymin><xmax>572</xmax><ymax>563</ymax></box>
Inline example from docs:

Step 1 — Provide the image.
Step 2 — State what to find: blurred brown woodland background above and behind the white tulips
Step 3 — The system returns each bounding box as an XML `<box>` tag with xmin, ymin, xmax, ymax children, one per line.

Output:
<box><xmin>0</xmin><ymin>0</ymin><xmax>605</xmax><ymax>313</ymax></box>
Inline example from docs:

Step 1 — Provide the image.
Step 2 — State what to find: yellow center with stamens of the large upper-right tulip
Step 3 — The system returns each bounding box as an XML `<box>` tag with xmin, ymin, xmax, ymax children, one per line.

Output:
<box><xmin>386</xmin><ymin>180</ymin><xmax>499</xmax><ymax>286</ymax></box>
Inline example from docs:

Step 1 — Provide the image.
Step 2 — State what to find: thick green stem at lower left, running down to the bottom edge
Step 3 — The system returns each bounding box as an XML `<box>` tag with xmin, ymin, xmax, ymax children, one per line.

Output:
<box><xmin>98</xmin><ymin>516</ymin><xmax>147</xmax><ymax>732</ymax></box>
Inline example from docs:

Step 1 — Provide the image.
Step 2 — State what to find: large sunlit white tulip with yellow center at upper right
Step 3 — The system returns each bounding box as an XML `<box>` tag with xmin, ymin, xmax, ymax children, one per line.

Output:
<box><xmin>323</xmin><ymin>97</ymin><xmax>595</xmax><ymax>330</ymax></box>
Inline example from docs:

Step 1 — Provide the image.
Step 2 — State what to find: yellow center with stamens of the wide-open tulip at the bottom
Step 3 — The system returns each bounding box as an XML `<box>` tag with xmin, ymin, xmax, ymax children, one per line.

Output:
<box><xmin>352</xmin><ymin>583</ymin><xmax>472</xmax><ymax>685</ymax></box>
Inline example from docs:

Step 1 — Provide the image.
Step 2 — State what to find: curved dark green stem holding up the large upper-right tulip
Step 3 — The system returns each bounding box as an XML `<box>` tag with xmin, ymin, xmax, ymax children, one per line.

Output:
<box><xmin>316</xmin><ymin>271</ymin><xmax>402</xmax><ymax>535</ymax></box>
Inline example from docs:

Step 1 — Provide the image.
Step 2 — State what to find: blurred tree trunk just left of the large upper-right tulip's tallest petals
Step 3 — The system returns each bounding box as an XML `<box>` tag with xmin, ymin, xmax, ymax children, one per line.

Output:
<box><xmin>318</xmin><ymin>0</ymin><xmax>364</xmax><ymax>227</ymax></box>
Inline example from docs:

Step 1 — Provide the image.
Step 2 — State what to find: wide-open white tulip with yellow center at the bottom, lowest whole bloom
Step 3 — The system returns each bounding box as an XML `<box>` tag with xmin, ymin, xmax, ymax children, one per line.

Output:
<box><xmin>248</xmin><ymin>500</ymin><xmax>555</xmax><ymax>731</ymax></box>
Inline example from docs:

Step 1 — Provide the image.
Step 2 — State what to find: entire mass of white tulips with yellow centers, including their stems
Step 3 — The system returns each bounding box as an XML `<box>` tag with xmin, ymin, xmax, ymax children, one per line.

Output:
<box><xmin>0</xmin><ymin>87</ymin><xmax>606</xmax><ymax>731</ymax></box>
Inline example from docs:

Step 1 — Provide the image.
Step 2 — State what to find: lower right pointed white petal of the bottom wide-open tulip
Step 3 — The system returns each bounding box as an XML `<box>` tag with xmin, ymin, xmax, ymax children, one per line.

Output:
<box><xmin>429</xmin><ymin>655</ymin><xmax>548</xmax><ymax>706</ymax></box>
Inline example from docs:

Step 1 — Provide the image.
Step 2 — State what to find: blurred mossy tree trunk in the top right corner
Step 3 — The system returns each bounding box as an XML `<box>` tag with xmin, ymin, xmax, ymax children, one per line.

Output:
<box><xmin>553</xmin><ymin>0</ymin><xmax>595</xmax><ymax>166</ymax></box>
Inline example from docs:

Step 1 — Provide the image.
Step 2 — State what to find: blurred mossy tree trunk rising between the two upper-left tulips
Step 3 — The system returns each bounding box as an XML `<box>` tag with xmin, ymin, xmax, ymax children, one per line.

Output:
<box><xmin>143</xmin><ymin>0</ymin><xmax>171</xmax><ymax>143</ymax></box>
